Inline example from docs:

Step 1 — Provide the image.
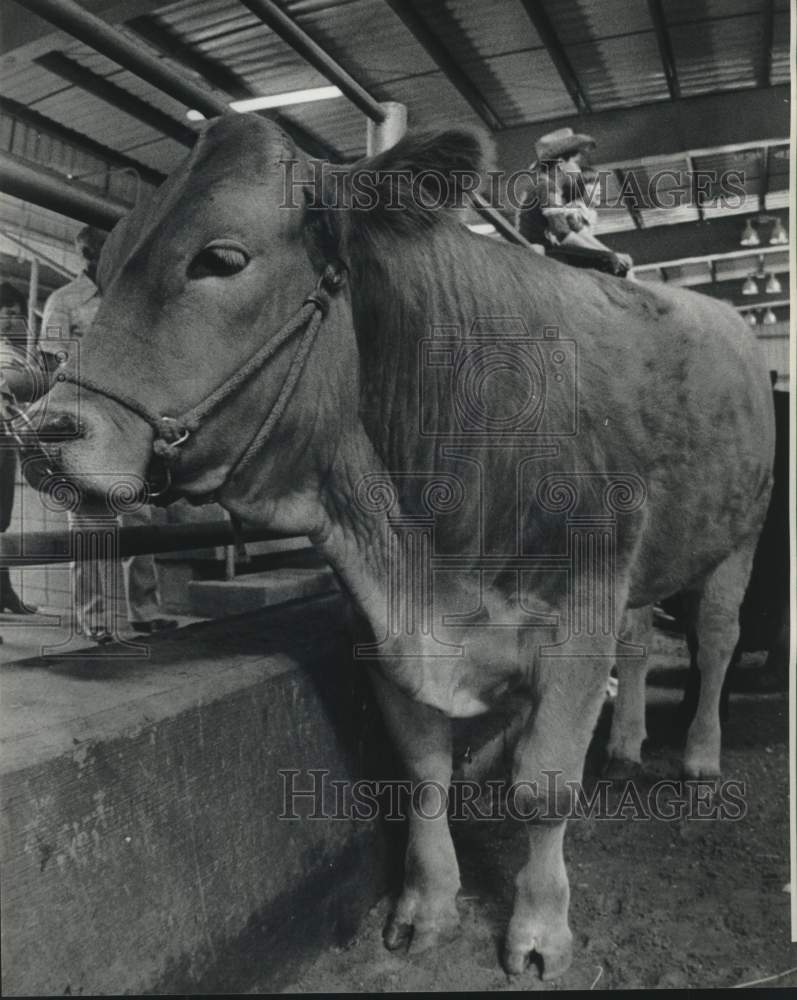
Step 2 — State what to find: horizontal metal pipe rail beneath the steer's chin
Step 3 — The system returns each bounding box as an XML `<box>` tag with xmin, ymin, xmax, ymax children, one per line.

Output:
<box><xmin>0</xmin><ymin>521</ymin><xmax>297</xmax><ymax>566</ymax></box>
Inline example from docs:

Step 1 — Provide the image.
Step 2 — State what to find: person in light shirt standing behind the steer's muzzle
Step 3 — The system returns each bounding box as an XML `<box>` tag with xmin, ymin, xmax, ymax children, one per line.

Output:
<box><xmin>42</xmin><ymin>226</ymin><xmax>177</xmax><ymax>643</ymax></box>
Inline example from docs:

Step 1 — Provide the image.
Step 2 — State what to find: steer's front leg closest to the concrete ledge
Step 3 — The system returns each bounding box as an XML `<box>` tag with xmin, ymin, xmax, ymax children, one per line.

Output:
<box><xmin>371</xmin><ymin>670</ymin><xmax>459</xmax><ymax>952</ymax></box>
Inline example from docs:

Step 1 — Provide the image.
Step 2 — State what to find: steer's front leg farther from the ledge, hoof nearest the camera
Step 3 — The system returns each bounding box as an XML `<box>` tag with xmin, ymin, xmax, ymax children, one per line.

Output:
<box><xmin>504</xmin><ymin>651</ymin><xmax>611</xmax><ymax>979</ymax></box>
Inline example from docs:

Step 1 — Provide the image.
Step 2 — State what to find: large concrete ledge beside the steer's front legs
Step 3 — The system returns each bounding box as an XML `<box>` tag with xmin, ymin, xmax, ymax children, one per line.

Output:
<box><xmin>0</xmin><ymin>596</ymin><xmax>385</xmax><ymax>995</ymax></box>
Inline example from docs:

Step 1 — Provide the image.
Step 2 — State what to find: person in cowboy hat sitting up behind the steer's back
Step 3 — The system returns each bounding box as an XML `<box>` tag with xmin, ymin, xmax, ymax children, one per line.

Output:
<box><xmin>516</xmin><ymin>128</ymin><xmax>633</xmax><ymax>275</ymax></box>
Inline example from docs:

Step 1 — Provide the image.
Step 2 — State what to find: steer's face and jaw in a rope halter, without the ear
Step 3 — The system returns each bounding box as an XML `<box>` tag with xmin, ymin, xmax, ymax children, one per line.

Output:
<box><xmin>34</xmin><ymin>115</ymin><xmax>486</xmax><ymax>533</ymax></box>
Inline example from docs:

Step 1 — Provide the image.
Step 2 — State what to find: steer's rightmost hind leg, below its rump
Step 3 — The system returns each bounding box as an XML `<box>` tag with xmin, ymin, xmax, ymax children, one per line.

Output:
<box><xmin>684</xmin><ymin>541</ymin><xmax>755</xmax><ymax>778</ymax></box>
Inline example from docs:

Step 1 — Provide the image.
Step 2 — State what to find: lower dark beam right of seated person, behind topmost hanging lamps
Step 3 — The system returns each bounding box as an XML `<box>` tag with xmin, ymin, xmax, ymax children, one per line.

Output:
<box><xmin>600</xmin><ymin>210</ymin><xmax>789</xmax><ymax>266</ymax></box>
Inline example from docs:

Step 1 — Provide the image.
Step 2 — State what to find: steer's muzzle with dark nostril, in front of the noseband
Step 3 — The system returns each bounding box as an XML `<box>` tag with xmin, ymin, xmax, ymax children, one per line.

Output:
<box><xmin>20</xmin><ymin>383</ymin><xmax>152</xmax><ymax>509</ymax></box>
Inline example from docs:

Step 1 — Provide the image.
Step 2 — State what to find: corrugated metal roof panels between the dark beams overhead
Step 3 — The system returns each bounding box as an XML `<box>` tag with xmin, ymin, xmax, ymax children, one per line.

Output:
<box><xmin>0</xmin><ymin>0</ymin><xmax>790</xmax><ymax>260</ymax></box>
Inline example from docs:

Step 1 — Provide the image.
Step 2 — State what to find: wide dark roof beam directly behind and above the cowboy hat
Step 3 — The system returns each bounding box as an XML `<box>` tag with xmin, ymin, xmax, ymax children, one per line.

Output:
<box><xmin>495</xmin><ymin>85</ymin><xmax>791</xmax><ymax>171</ymax></box>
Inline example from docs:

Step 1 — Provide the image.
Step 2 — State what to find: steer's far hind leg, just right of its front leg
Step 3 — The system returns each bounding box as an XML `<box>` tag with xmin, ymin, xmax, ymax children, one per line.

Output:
<box><xmin>606</xmin><ymin>606</ymin><xmax>653</xmax><ymax>778</ymax></box>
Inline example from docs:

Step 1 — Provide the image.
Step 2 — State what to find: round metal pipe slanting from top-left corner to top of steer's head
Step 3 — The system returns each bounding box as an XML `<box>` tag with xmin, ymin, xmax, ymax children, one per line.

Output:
<box><xmin>12</xmin><ymin>0</ymin><xmax>227</xmax><ymax>116</ymax></box>
